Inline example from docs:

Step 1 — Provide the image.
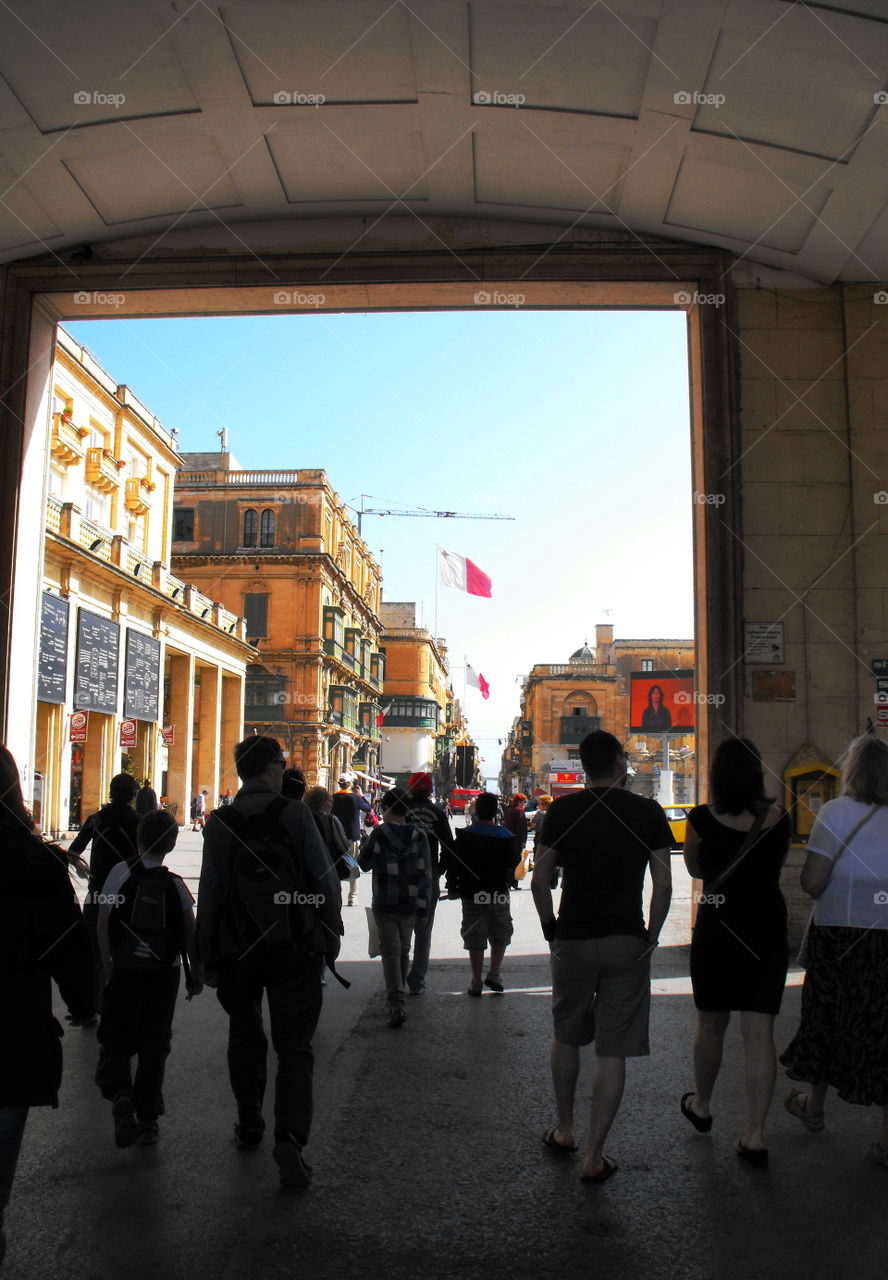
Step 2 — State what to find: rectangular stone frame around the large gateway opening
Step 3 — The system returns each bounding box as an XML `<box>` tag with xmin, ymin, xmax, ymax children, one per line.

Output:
<box><xmin>0</xmin><ymin>238</ymin><xmax>742</xmax><ymax>796</ymax></box>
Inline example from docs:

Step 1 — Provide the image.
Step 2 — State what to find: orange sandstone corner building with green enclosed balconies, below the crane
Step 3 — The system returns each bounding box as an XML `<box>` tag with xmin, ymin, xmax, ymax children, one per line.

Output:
<box><xmin>173</xmin><ymin>452</ymin><xmax>385</xmax><ymax>786</ymax></box>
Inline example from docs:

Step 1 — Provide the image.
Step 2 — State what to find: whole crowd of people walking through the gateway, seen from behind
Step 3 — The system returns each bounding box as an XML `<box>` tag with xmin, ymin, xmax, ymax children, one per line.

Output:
<box><xmin>0</xmin><ymin>731</ymin><xmax>888</xmax><ymax>1264</ymax></box>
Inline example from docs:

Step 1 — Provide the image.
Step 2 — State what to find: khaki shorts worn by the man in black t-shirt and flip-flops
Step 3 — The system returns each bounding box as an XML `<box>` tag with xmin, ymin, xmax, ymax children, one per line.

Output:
<box><xmin>551</xmin><ymin>933</ymin><xmax>650</xmax><ymax>1057</ymax></box>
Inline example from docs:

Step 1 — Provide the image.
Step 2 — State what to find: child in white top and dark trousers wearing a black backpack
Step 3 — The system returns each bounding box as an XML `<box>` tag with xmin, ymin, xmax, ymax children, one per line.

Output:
<box><xmin>96</xmin><ymin>809</ymin><xmax>203</xmax><ymax>1147</ymax></box>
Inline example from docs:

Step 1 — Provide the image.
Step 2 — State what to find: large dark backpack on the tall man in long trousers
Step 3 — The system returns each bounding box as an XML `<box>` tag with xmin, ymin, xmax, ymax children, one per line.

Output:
<box><xmin>211</xmin><ymin>796</ymin><xmax>317</xmax><ymax>955</ymax></box>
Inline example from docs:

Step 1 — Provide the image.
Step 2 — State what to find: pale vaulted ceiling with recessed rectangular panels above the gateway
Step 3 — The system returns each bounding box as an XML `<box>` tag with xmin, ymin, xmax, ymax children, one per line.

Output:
<box><xmin>0</xmin><ymin>0</ymin><xmax>888</xmax><ymax>282</ymax></box>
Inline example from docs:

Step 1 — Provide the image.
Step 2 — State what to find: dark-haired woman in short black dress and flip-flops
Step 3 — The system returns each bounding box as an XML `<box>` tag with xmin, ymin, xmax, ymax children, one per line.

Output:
<box><xmin>681</xmin><ymin>739</ymin><xmax>789</xmax><ymax>1167</ymax></box>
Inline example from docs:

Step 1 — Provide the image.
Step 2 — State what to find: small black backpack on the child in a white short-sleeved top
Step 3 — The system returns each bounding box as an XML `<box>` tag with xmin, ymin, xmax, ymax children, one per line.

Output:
<box><xmin>107</xmin><ymin>861</ymin><xmax>186</xmax><ymax>974</ymax></box>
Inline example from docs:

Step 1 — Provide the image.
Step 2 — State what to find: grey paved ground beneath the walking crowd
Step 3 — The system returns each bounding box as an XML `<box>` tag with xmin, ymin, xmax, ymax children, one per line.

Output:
<box><xmin>5</xmin><ymin>832</ymin><xmax>888</xmax><ymax>1280</ymax></box>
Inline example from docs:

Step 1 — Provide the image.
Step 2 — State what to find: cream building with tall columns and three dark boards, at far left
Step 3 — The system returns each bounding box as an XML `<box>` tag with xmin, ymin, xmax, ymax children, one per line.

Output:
<box><xmin>33</xmin><ymin>329</ymin><xmax>253</xmax><ymax>835</ymax></box>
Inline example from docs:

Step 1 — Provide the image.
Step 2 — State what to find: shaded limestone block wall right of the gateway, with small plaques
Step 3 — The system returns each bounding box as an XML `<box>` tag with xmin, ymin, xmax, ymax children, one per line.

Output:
<box><xmin>738</xmin><ymin>284</ymin><xmax>888</xmax><ymax>933</ymax></box>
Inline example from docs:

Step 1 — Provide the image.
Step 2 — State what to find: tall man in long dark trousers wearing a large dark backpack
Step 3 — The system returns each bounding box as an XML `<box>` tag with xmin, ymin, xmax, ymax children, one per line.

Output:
<box><xmin>197</xmin><ymin>735</ymin><xmax>343</xmax><ymax>1187</ymax></box>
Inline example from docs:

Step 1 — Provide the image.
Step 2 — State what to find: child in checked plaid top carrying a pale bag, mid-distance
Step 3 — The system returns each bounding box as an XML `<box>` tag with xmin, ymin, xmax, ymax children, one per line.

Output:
<box><xmin>358</xmin><ymin>790</ymin><xmax>431</xmax><ymax>1027</ymax></box>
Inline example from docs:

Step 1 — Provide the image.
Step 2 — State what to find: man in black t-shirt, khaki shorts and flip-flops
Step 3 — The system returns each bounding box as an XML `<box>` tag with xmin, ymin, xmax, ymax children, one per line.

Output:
<box><xmin>531</xmin><ymin>731</ymin><xmax>672</xmax><ymax>1183</ymax></box>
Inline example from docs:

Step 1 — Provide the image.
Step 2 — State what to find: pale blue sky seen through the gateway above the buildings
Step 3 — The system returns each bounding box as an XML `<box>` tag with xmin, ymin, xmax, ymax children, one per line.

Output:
<box><xmin>65</xmin><ymin>310</ymin><xmax>692</xmax><ymax>776</ymax></box>
